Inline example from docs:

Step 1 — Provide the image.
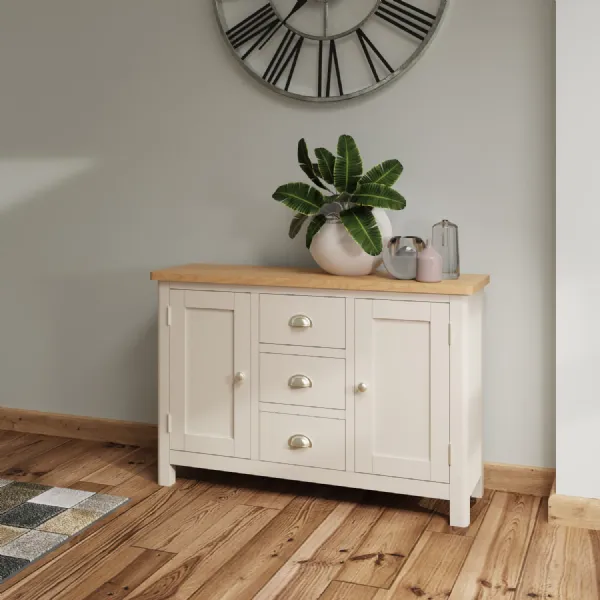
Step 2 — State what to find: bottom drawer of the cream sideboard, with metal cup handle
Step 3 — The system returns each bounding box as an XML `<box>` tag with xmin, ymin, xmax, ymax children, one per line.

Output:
<box><xmin>260</xmin><ymin>412</ymin><xmax>346</xmax><ymax>471</ymax></box>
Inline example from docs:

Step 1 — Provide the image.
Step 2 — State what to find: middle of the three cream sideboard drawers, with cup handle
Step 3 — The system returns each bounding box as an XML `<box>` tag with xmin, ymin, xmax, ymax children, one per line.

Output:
<box><xmin>259</xmin><ymin>354</ymin><xmax>346</xmax><ymax>410</ymax></box>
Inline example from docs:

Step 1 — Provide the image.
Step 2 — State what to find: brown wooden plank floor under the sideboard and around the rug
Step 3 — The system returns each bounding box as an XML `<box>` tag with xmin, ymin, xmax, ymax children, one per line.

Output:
<box><xmin>0</xmin><ymin>432</ymin><xmax>600</xmax><ymax>600</ymax></box>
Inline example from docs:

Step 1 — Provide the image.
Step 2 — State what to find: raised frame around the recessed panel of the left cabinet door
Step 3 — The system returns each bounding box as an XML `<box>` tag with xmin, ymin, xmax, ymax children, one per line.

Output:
<box><xmin>169</xmin><ymin>289</ymin><xmax>251</xmax><ymax>458</ymax></box>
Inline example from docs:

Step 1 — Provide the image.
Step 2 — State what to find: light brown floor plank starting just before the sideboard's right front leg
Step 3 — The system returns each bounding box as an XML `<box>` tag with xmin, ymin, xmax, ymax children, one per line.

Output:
<box><xmin>375</xmin><ymin>531</ymin><xmax>473</xmax><ymax>600</ymax></box>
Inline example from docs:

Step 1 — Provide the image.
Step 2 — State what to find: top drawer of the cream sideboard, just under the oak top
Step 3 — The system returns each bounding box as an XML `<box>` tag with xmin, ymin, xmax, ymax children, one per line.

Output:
<box><xmin>260</xmin><ymin>294</ymin><xmax>346</xmax><ymax>348</ymax></box>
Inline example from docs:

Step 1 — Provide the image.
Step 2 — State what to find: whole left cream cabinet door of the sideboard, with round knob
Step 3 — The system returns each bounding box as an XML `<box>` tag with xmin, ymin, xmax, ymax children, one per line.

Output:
<box><xmin>170</xmin><ymin>290</ymin><xmax>250</xmax><ymax>458</ymax></box>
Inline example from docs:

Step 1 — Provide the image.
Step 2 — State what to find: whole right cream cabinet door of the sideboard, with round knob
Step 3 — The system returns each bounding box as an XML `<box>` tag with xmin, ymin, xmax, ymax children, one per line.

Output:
<box><xmin>355</xmin><ymin>300</ymin><xmax>450</xmax><ymax>483</ymax></box>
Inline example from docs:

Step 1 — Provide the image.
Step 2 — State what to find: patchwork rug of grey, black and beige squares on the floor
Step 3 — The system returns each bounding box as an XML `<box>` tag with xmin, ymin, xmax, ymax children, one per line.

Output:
<box><xmin>0</xmin><ymin>479</ymin><xmax>129</xmax><ymax>583</ymax></box>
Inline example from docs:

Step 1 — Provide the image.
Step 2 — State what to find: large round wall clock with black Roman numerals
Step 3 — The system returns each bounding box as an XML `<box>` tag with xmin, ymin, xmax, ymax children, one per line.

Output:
<box><xmin>215</xmin><ymin>0</ymin><xmax>447</xmax><ymax>102</ymax></box>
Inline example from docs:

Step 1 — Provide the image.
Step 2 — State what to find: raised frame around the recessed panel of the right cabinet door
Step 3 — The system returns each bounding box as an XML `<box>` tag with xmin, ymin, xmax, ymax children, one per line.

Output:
<box><xmin>354</xmin><ymin>299</ymin><xmax>450</xmax><ymax>483</ymax></box>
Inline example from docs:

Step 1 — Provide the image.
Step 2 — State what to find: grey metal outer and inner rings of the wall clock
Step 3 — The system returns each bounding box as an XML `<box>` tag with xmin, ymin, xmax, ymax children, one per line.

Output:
<box><xmin>214</xmin><ymin>0</ymin><xmax>449</xmax><ymax>102</ymax></box>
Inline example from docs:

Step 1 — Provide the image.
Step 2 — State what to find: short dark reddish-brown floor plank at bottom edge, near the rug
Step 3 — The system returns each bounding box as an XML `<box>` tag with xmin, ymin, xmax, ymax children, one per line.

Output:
<box><xmin>78</xmin><ymin>550</ymin><xmax>175</xmax><ymax>600</ymax></box>
